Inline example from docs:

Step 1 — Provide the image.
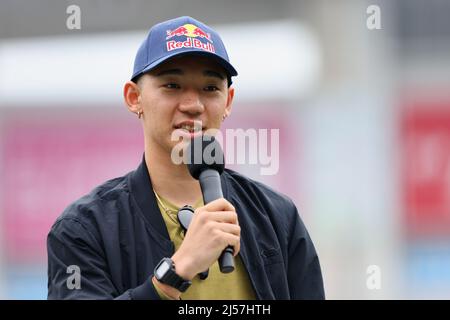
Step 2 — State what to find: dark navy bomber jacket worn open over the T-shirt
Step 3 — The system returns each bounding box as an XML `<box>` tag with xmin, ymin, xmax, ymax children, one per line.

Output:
<box><xmin>47</xmin><ymin>156</ymin><xmax>324</xmax><ymax>299</ymax></box>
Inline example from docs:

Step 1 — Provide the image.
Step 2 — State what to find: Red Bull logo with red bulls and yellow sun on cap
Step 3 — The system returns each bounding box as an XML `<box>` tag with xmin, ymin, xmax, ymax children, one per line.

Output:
<box><xmin>166</xmin><ymin>23</ymin><xmax>215</xmax><ymax>53</ymax></box>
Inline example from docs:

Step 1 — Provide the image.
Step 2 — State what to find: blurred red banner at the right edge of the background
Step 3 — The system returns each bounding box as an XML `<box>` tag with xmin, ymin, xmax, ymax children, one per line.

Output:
<box><xmin>401</xmin><ymin>99</ymin><xmax>450</xmax><ymax>235</ymax></box>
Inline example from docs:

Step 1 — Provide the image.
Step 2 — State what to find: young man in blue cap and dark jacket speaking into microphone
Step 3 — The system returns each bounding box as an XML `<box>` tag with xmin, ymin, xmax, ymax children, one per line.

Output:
<box><xmin>47</xmin><ymin>17</ymin><xmax>324</xmax><ymax>299</ymax></box>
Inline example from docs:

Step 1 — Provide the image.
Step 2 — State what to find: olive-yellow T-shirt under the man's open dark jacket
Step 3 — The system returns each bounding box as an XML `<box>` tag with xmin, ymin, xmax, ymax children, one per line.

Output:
<box><xmin>156</xmin><ymin>192</ymin><xmax>256</xmax><ymax>300</ymax></box>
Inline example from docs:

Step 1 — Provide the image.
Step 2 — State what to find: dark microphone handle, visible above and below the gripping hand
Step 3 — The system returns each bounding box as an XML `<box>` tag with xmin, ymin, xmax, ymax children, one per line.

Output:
<box><xmin>199</xmin><ymin>169</ymin><xmax>234</xmax><ymax>273</ymax></box>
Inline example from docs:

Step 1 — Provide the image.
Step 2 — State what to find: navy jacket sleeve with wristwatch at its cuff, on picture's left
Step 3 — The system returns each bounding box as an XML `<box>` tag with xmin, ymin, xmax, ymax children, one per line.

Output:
<box><xmin>47</xmin><ymin>218</ymin><xmax>160</xmax><ymax>300</ymax></box>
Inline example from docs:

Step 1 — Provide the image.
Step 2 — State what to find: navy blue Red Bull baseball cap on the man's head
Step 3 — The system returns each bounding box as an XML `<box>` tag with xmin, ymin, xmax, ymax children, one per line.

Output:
<box><xmin>131</xmin><ymin>16</ymin><xmax>237</xmax><ymax>81</ymax></box>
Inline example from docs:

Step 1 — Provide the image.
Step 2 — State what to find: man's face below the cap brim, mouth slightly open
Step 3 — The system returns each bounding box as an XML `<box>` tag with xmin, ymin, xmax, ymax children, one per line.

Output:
<box><xmin>139</xmin><ymin>56</ymin><xmax>234</xmax><ymax>158</ymax></box>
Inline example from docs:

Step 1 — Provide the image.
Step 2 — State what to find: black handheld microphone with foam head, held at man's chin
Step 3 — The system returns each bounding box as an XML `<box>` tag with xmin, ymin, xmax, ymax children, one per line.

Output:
<box><xmin>185</xmin><ymin>135</ymin><xmax>234</xmax><ymax>273</ymax></box>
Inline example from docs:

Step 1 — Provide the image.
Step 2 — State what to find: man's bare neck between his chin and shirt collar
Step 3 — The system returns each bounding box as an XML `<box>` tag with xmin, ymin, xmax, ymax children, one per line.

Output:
<box><xmin>145</xmin><ymin>143</ymin><xmax>202</xmax><ymax>207</ymax></box>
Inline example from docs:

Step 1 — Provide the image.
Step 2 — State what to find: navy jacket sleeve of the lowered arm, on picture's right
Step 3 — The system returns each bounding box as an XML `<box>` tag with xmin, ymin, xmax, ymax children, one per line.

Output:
<box><xmin>288</xmin><ymin>203</ymin><xmax>325</xmax><ymax>300</ymax></box>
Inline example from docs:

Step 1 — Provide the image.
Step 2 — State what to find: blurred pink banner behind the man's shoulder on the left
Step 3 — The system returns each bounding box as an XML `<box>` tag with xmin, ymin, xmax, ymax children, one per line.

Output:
<box><xmin>0</xmin><ymin>112</ymin><xmax>144</xmax><ymax>262</ymax></box>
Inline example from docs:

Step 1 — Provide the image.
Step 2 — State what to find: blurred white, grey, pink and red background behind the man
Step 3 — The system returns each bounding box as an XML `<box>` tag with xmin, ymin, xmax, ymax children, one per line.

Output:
<box><xmin>0</xmin><ymin>0</ymin><xmax>450</xmax><ymax>299</ymax></box>
